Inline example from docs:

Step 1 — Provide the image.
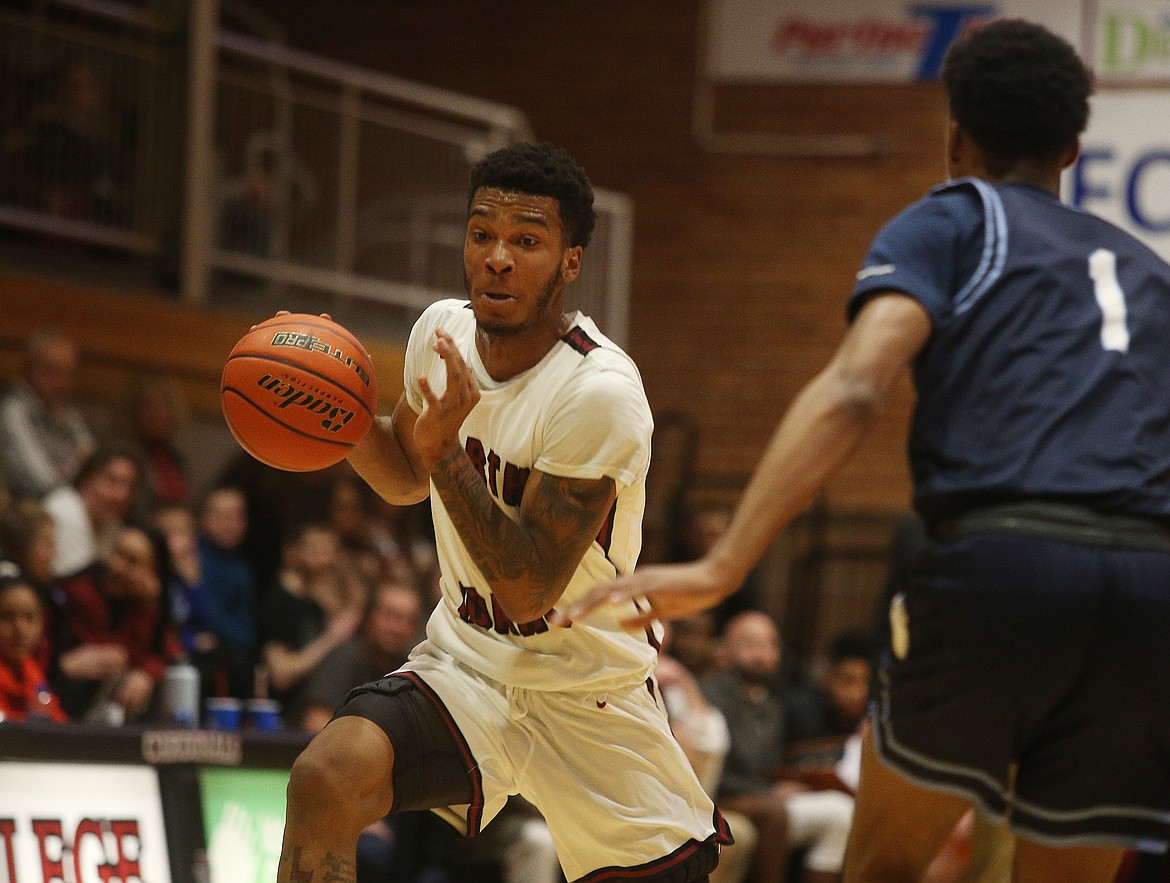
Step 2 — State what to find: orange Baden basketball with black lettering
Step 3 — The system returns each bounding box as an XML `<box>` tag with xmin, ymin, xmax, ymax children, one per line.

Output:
<box><xmin>220</xmin><ymin>313</ymin><xmax>378</xmax><ymax>472</ymax></box>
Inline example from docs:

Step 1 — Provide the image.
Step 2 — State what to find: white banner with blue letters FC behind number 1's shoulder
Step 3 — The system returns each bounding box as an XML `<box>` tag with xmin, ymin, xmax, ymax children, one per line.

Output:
<box><xmin>1062</xmin><ymin>90</ymin><xmax>1170</xmax><ymax>261</ymax></box>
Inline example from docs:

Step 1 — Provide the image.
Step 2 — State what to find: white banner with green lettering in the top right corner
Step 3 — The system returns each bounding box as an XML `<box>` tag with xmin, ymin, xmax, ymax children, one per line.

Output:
<box><xmin>1086</xmin><ymin>0</ymin><xmax>1170</xmax><ymax>83</ymax></box>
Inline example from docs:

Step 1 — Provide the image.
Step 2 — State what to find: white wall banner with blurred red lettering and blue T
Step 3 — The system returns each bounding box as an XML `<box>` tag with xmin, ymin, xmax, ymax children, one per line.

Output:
<box><xmin>707</xmin><ymin>0</ymin><xmax>1083</xmax><ymax>83</ymax></box>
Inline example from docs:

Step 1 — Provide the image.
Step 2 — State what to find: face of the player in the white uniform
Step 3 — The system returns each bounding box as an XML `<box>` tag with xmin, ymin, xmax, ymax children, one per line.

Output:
<box><xmin>463</xmin><ymin>187</ymin><xmax>581</xmax><ymax>337</ymax></box>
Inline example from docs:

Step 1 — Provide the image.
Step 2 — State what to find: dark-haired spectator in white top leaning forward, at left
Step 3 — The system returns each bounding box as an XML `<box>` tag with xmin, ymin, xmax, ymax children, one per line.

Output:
<box><xmin>43</xmin><ymin>447</ymin><xmax>139</xmax><ymax>577</ymax></box>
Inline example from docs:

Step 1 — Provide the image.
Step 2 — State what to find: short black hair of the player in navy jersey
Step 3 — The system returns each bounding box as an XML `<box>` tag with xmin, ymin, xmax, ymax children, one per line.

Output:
<box><xmin>942</xmin><ymin>19</ymin><xmax>1093</xmax><ymax>171</ymax></box>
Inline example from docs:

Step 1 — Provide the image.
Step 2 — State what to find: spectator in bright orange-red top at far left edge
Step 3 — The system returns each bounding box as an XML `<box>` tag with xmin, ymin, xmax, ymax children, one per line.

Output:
<box><xmin>0</xmin><ymin>561</ymin><xmax>68</xmax><ymax>722</ymax></box>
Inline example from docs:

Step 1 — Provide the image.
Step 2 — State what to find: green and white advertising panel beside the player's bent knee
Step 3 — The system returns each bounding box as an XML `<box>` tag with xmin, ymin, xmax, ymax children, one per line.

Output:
<box><xmin>199</xmin><ymin>767</ymin><xmax>289</xmax><ymax>883</ymax></box>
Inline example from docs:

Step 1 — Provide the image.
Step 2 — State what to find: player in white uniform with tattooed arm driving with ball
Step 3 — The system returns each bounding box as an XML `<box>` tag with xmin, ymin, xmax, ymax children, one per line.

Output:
<box><xmin>278</xmin><ymin>144</ymin><xmax>729</xmax><ymax>883</ymax></box>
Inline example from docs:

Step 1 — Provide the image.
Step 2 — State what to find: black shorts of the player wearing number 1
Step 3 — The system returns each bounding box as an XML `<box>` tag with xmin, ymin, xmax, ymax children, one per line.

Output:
<box><xmin>874</xmin><ymin>523</ymin><xmax>1170</xmax><ymax>851</ymax></box>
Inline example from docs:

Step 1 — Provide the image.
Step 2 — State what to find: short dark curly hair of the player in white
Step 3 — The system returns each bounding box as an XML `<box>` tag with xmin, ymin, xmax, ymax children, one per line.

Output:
<box><xmin>467</xmin><ymin>142</ymin><xmax>597</xmax><ymax>247</ymax></box>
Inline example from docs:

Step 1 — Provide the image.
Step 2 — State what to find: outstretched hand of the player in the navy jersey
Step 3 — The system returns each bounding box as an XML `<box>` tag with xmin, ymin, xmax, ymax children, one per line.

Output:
<box><xmin>551</xmin><ymin>558</ymin><xmax>735</xmax><ymax>629</ymax></box>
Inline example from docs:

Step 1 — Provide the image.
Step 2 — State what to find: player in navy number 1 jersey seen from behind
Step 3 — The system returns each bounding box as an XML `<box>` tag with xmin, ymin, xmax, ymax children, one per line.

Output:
<box><xmin>562</xmin><ymin>21</ymin><xmax>1170</xmax><ymax>883</ymax></box>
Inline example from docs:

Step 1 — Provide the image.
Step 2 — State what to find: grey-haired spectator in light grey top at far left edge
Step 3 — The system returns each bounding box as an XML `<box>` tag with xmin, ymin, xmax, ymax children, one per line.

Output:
<box><xmin>0</xmin><ymin>331</ymin><xmax>94</xmax><ymax>497</ymax></box>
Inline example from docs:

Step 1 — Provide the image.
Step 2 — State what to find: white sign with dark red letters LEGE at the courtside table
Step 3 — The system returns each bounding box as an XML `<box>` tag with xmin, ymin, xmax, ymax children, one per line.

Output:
<box><xmin>0</xmin><ymin>761</ymin><xmax>171</xmax><ymax>883</ymax></box>
